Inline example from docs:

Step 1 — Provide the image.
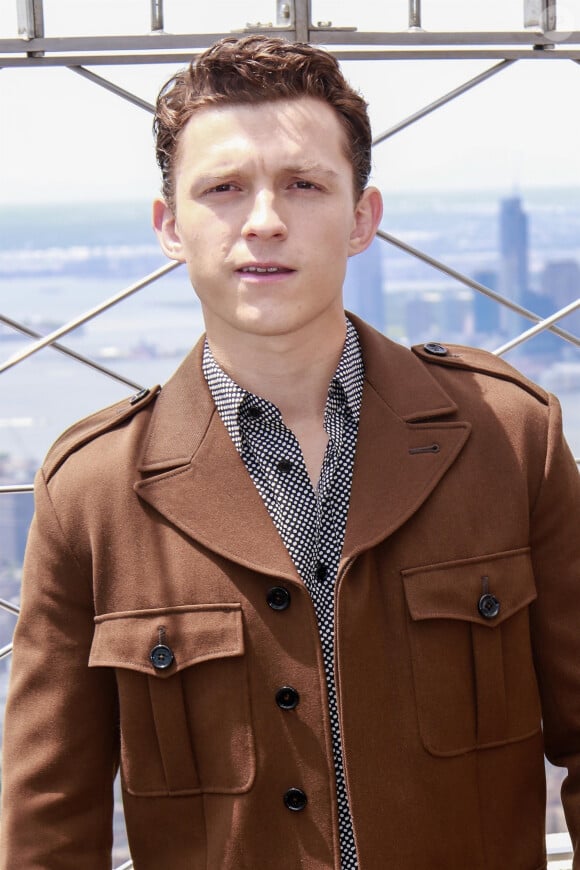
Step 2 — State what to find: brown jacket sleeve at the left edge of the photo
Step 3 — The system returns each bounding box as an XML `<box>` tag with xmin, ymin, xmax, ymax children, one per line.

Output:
<box><xmin>0</xmin><ymin>472</ymin><xmax>118</xmax><ymax>870</ymax></box>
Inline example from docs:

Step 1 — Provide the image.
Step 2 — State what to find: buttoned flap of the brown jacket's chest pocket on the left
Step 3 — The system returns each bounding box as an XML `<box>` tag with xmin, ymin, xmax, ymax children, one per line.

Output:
<box><xmin>89</xmin><ymin>604</ymin><xmax>244</xmax><ymax>677</ymax></box>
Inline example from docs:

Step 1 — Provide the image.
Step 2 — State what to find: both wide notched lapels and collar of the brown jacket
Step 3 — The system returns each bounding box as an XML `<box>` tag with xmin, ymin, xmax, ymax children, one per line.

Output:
<box><xmin>135</xmin><ymin>315</ymin><xmax>470</xmax><ymax>581</ymax></box>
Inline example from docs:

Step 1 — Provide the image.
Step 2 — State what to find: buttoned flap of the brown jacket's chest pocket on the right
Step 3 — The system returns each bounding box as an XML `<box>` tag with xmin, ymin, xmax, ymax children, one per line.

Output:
<box><xmin>401</xmin><ymin>547</ymin><xmax>537</xmax><ymax>628</ymax></box>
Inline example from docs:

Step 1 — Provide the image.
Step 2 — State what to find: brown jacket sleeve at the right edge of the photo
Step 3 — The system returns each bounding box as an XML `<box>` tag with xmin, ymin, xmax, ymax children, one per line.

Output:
<box><xmin>531</xmin><ymin>397</ymin><xmax>580</xmax><ymax>870</ymax></box>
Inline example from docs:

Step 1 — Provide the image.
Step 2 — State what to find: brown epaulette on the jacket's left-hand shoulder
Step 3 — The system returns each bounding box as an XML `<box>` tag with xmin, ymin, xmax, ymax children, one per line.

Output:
<box><xmin>43</xmin><ymin>385</ymin><xmax>161</xmax><ymax>481</ymax></box>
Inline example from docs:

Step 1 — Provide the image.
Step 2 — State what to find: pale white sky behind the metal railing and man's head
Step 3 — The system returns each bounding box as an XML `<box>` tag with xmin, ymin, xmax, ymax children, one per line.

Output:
<box><xmin>0</xmin><ymin>0</ymin><xmax>580</xmax><ymax>207</ymax></box>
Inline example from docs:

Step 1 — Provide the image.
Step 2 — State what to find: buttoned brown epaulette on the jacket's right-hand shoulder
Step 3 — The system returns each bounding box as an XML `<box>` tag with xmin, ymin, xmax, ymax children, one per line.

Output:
<box><xmin>411</xmin><ymin>341</ymin><xmax>549</xmax><ymax>405</ymax></box>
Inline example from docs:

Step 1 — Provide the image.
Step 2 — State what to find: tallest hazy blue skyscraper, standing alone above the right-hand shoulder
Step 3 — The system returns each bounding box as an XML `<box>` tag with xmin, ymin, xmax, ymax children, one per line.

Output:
<box><xmin>498</xmin><ymin>196</ymin><xmax>529</xmax><ymax>336</ymax></box>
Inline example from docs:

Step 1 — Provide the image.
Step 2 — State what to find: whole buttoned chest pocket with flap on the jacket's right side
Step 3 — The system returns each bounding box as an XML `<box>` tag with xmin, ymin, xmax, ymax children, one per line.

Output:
<box><xmin>402</xmin><ymin>549</ymin><xmax>541</xmax><ymax>756</ymax></box>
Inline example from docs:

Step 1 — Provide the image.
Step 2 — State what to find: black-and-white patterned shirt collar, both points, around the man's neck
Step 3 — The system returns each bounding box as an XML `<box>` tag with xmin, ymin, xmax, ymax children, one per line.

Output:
<box><xmin>202</xmin><ymin>318</ymin><xmax>364</xmax><ymax>453</ymax></box>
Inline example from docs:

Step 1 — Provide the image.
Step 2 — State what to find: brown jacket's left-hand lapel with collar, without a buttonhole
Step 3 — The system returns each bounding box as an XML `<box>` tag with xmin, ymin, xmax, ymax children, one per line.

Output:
<box><xmin>135</xmin><ymin>340</ymin><xmax>298</xmax><ymax>580</ymax></box>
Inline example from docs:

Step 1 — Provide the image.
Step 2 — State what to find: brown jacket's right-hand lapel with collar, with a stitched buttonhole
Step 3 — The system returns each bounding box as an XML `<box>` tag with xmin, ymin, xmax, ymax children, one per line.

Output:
<box><xmin>343</xmin><ymin>315</ymin><xmax>471</xmax><ymax>562</ymax></box>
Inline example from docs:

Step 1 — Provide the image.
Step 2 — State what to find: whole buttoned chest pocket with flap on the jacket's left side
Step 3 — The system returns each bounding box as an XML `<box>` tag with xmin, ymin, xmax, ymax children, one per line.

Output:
<box><xmin>89</xmin><ymin>604</ymin><xmax>255</xmax><ymax>796</ymax></box>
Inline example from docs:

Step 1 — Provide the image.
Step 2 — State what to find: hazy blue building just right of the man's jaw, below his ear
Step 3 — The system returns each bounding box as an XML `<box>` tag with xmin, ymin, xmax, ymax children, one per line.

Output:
<box><xmin>344</xmin><ymin>238</ymin><xmax>386</xmax><ymax>332</ymax></box>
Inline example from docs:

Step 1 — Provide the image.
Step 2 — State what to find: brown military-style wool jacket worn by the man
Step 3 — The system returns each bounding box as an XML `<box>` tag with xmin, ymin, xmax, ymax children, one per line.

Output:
<box><xmin>0</xmin><ymin>320</ymin><xmax>580</xmax><ymax>870</ymax></box>
